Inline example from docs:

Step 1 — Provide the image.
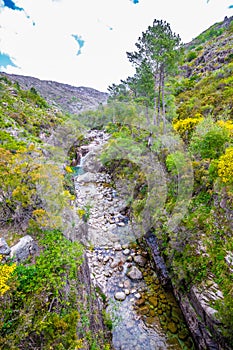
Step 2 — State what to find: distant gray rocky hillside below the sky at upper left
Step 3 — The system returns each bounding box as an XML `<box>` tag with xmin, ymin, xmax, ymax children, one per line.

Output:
<box><xmin>1</xmin><ymin>73</ymin><xmax>108</xmax><ymax>114</ymax></box>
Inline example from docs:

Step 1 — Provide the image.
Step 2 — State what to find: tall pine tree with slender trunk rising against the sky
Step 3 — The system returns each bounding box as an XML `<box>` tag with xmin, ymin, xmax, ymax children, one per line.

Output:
<box><xmin>127</xmin><ymin>20</ymin><xmax>181</xmax><ymax>128</ymax></box>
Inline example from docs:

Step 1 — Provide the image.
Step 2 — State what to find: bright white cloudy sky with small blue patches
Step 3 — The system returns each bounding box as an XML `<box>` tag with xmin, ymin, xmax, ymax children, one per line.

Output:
<box><xmin>0</xmin><ymin>0</ymin><xmax>233</xmax><ymax>91</ymax></box>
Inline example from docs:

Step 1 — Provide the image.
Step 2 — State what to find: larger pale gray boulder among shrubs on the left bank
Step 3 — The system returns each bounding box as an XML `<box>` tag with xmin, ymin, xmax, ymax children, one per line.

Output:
<box><xmin>10</xmin><ymin>235</ymin><xmax>38</xmax><ymax>261</ymax></box>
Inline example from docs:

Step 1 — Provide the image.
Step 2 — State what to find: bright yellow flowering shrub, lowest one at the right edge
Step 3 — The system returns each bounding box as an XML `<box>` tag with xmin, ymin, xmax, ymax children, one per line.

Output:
<box><xmin>218</xmin><ymin>147</ymin><xmax>233</xmax><ymax>184</ymax></box>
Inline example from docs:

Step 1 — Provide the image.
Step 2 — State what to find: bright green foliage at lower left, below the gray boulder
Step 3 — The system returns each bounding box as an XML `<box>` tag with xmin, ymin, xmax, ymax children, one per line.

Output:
<box><xmin>0</xmin><ymin>231</ymin><xmax>83</xmax><ymax>350</ymax></box>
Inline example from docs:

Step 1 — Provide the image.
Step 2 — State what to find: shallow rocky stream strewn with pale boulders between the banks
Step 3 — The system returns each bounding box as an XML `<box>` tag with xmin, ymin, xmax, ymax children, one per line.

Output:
<box><xmin>74</xmin><ymin>130</ymin><xmax>195</xmax><ymax>350</ymax></box>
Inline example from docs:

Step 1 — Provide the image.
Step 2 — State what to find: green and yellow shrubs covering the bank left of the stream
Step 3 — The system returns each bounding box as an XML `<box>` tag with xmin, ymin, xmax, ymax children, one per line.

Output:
<box><xmin>0</xmin><ymin>76</ymin><xmax>109</xmax><ymax>350</ymax></box>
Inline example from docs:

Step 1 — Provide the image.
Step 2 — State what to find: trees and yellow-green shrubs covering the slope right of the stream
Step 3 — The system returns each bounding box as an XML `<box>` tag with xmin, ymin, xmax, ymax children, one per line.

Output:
<box><xmin>80</xmin><ymin>15</ymin><xmax>233</xmax><ymax>346</ymax></box>
